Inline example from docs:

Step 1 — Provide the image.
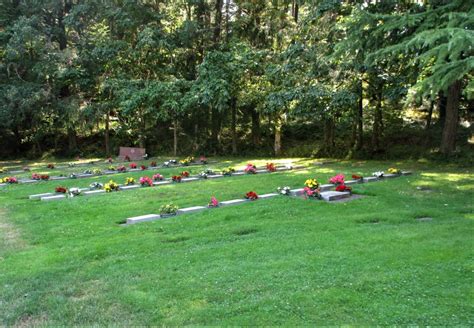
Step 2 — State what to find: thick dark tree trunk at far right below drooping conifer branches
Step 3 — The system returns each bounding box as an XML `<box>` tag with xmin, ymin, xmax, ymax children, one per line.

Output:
<box><xmin>441</xmin><ymin>81</ymin><xmax>461</xmax><ymax>155</ymax></box>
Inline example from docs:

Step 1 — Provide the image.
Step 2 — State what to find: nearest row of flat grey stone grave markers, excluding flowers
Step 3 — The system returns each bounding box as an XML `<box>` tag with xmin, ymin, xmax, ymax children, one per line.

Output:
<box><xmin>124</xmin><ymin>172</ymin><xmax>412</xmax><ymax>225</ymax></box>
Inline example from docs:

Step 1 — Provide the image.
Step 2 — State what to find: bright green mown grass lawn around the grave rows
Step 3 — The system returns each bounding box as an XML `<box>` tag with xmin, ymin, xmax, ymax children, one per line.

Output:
<box><xmin>0</xmin><ymin>159</ymin><xmax>474</xmax><ymax>326</ymax></box>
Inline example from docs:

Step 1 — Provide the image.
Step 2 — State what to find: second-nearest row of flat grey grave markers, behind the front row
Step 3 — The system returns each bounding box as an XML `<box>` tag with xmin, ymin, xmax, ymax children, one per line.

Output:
<box><xmin>29</xmin><ymin>165</ymin><xmax>306</xmax><ymax>201</ymax></box>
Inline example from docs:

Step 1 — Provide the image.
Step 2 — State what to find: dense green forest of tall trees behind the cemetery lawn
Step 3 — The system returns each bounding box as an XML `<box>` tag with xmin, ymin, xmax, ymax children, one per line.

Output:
<box><xmin>0</xmin><ymin>0</ymin><xmax>474</xmax><ymax>158</ymax></box>
